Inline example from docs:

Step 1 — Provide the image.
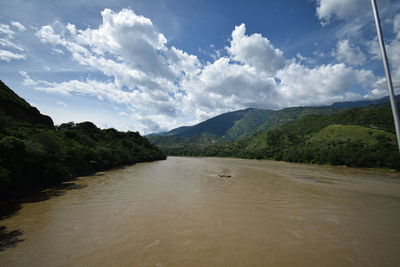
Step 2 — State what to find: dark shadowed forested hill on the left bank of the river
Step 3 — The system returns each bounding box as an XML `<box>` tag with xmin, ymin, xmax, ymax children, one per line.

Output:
<box><xmin>0</xmin><ymin>82</ymin><xmax>166</xmax><ymax>198</ymax></box>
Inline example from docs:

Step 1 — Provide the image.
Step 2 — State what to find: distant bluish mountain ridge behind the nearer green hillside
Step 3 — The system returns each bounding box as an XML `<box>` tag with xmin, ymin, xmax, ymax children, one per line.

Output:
<box><xmin>146</xmin><ymin>97</ymin><xmax>396</xmax><ymax>149</ymax></box>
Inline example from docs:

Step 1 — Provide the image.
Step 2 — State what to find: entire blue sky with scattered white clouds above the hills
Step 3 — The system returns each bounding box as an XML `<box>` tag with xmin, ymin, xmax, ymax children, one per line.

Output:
<box><xmin>0</xmin><ymin>0</ymin><xmax>400</xmax><ymax>134</ymax></box>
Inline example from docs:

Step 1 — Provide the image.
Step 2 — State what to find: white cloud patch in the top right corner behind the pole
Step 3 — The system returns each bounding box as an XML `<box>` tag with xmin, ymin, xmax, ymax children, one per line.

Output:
<box><xmin>316</xmin><ymin>0</ymin><xmax>400</xmax><ymax>88</ymax></box>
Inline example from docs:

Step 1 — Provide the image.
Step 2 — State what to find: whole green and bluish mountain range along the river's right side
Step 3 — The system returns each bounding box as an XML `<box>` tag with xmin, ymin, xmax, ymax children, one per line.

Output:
<box><xmin>147</xmin><ymin>97</ymin><xmax>400</xmax><ymax>170</ymax></box>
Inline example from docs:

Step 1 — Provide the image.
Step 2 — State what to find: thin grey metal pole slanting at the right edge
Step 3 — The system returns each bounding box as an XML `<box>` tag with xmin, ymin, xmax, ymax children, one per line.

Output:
<box><xmin>371</xmin><ymin>0</ymin><xmax>400</xmax><ymax>151</ymax></box>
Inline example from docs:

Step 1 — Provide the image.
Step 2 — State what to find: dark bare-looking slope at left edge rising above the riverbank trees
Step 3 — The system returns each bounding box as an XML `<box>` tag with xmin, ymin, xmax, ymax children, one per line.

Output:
<box><xmin>0</xmin><ymin>81</ymin><xmax>54</xmax><ymax>129</ymax></box>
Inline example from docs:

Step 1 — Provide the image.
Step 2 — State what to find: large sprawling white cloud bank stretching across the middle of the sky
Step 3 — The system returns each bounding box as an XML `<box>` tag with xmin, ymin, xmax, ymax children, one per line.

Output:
<box><xmin>28</xmin><ymin>9</ymin><xmax>384</xmax><ymax>133</ymax></box>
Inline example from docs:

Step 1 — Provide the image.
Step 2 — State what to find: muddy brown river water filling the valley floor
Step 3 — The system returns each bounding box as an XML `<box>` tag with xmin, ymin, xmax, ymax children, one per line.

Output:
<box><xmin>0</xmin><ymin>157</ymin><xmax>400</xmax><ymax>267</ymax></box>
